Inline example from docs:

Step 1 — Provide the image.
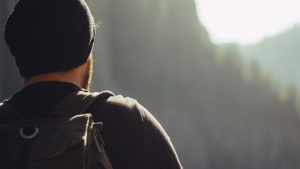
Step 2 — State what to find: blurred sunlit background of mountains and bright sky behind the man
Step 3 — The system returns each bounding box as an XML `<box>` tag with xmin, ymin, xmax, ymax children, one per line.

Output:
<box><xmin>0</xmin><ymin>0</ymin><xmax>300</xmax><ymax>169</ymax></box>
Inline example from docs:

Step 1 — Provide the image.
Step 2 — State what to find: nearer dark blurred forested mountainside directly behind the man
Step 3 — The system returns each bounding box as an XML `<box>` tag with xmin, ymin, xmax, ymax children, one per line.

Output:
<box><xmin>0</xmin><ymin>0</ymin><xmax>300</xmax><ymax>169</ymax></box>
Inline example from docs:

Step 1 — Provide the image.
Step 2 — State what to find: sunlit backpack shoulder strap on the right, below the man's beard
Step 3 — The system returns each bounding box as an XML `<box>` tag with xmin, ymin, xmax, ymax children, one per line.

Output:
<box><xmin>56</xmin><ymin>91</ymin><xmax>114</xmax><ymax>116</ymax></box>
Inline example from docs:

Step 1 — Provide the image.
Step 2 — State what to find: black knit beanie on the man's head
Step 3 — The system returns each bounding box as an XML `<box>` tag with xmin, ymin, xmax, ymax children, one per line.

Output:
<box><xmin>5</xmin><ymin>0</ymin><xmax>95</xmax><ymax>77</ymax></box>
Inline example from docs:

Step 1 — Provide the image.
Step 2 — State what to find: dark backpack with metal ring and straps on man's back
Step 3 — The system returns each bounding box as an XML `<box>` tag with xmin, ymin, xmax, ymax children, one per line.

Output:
<box><xmin>0</xmin><ymin>91</ymin><xmax>113</xmax><ymax>169</ymax></box>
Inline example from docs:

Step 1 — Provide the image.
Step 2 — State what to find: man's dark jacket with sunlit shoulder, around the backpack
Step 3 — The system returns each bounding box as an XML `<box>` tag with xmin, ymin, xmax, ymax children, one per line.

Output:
<box><xmin>8</xmin><ymin>82</ymin><xmax>181</xmax><ymax>169</ymax></box>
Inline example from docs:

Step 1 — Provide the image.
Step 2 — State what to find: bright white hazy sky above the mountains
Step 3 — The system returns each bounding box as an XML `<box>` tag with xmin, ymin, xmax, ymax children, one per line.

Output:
<box><xmin>195</xmin><ymin>0</ymin><xmax>300</xmax><ymax>44</ymax></box>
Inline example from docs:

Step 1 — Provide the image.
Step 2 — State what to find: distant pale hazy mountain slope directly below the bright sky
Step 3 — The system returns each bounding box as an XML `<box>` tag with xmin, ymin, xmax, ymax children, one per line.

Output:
<box><xmin>239</xmin><ymin>25</ymin><xmax>300</xmax><ymax>91</ymax></box>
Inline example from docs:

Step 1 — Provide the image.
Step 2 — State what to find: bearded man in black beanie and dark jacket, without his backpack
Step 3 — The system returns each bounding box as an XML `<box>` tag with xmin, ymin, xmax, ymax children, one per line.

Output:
<box><xmin>1</xmin><ymin>0</ymin><xmax>181</xmax><ymax>169</ymax></box>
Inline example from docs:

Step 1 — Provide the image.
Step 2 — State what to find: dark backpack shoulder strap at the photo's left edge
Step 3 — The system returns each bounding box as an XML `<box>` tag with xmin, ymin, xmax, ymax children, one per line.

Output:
<box><xmin>0</xmin><ymin>101</ymin><xmax>25</xmax><ymax>124</ymax></box>
